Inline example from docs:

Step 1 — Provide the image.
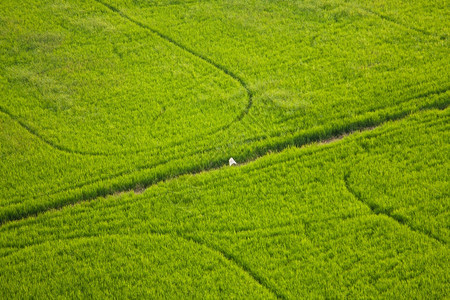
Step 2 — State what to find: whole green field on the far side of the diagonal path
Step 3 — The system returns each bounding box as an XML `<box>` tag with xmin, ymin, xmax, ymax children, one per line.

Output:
<box><xmin>0</xmin><ymin>0</ymin><xmax>450</xmax><ymax>223</ymax></box>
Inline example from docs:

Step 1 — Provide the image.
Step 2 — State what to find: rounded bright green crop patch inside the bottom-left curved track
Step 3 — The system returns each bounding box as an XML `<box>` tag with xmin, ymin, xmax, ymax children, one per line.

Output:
<box><xmin>1</xmin><ymin>234</ymin><xmax>271</xmax><ymax>299</ymax></box>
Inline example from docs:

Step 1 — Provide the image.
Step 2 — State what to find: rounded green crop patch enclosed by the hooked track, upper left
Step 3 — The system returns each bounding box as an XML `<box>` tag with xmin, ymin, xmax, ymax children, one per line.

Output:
<box><xmin>1</xmin><ymin>1</ymin><xmax>248</xmax><ymax>154</ymax></box>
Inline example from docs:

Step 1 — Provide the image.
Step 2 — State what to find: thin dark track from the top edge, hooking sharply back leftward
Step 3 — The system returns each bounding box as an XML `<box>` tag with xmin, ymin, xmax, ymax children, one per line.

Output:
<box><xmin>94</xmin><ymin>0</ymin><xmax>253</xmax><ymax>127</ymax></box>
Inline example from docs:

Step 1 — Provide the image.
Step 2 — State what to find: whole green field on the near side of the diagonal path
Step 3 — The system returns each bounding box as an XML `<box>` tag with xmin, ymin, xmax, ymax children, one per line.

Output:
<box><xmin>0</xmin><ymin>109</ymin><xmax>450</xmax><ymax>299</ymax></box>
